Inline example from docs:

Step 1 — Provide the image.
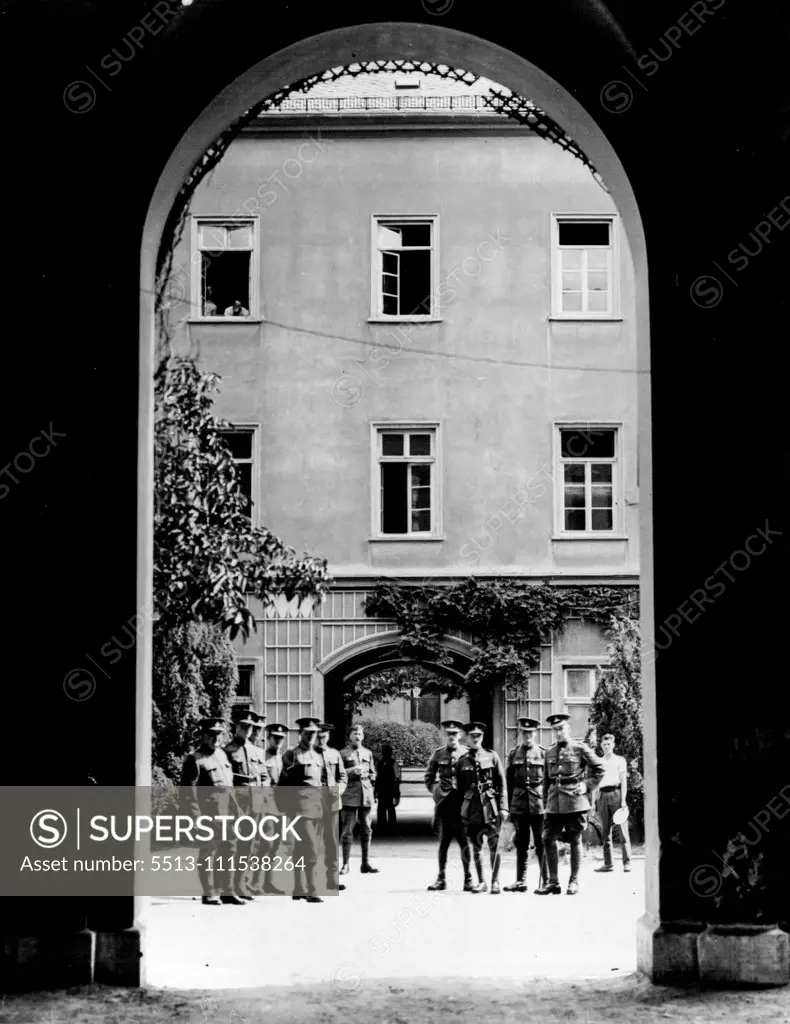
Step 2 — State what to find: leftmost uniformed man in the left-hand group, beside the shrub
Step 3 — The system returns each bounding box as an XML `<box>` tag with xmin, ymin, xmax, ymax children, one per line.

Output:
<box><xmin>179</xmin><ymin>718</ymin><xmax>244</xmax><ymax>906</ymax></box>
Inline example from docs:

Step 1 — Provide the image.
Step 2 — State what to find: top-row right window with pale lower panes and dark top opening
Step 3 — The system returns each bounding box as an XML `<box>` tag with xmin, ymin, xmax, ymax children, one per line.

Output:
<box><xmin>551</xmin><ymin>215</ymin><xmax>619</xmax><ymax>319</ymax></box>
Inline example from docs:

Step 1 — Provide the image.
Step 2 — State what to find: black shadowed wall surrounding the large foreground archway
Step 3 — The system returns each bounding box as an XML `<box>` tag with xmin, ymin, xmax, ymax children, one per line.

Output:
<box><xmin>0</xmin><ymin>0</ymin><xmax>790</xmax><ymax>983</ymax></box>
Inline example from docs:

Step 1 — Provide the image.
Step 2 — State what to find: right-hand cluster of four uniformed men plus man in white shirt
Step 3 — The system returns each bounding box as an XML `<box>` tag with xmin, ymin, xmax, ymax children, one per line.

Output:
<box><xmin>425</xmin><ymin>714</ymin><xmax>630</xmax><ymax>896</ymax></box>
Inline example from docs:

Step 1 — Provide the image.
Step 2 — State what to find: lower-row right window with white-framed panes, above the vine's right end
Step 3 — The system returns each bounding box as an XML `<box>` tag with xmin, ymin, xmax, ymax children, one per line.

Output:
<box><xmin>556</xmin><ymin>424</ymin><xmax>620</xmax><ymax>536</ymax></box>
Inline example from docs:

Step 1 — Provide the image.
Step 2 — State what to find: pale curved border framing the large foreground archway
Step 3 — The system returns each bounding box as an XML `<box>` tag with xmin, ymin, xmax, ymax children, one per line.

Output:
<box><xmin>137</xmin><ymin>18</ymin><xmax>658</xmax><ymax>991</ymax></box>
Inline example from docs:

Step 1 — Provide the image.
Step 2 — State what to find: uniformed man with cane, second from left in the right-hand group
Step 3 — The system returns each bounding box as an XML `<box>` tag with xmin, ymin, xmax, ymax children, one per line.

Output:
<box><xmin>455</xmin><ymin>722</ymin><xmax>507</xmax><ymax>896</ymax></box>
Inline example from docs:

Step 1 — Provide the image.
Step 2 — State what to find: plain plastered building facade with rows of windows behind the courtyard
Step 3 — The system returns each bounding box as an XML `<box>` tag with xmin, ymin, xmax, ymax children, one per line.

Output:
<box><xmin>168</xmin><ymin>66</ymin><xmax>638</xmax><ymax>752</ymax></box>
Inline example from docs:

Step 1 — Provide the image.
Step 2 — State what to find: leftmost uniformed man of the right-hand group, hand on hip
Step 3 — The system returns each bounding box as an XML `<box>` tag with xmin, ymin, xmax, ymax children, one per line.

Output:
<box><xmin>425</xmin><ymin>719</ymin><xmax>472</xmax><ymax>892</ymax></box>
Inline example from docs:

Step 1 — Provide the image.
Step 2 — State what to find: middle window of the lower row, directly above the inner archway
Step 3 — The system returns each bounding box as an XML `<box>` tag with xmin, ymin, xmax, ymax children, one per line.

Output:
<box><xmin>374</xmin><ymin>424</ymin><xmax>440</xmax><ymax>538</ymax></box>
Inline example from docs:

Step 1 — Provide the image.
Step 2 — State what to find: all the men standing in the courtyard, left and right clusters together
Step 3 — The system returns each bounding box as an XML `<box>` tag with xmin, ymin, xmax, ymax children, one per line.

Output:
<box><xmin>180</xmin><ymin>712</ymin><xmax>630</xmax><ymax>906</ymax></box>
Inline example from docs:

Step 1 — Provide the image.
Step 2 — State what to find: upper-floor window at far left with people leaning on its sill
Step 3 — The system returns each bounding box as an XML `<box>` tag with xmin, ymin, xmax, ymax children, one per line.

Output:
<box><xmin>192</xmin><ymin>217</ymin><xmax>258</xmax><ymax>321</ymax></box>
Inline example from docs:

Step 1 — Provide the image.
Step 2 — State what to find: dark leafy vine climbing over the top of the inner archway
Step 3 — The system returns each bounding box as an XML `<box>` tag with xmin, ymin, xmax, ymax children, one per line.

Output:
<box><xmin>364</xmin><ymin>578</ymin><xmax>638</xmax><ymax>699</ymax></box>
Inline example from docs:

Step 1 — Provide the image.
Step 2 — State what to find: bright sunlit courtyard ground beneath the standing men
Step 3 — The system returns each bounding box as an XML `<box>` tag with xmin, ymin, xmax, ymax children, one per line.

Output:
<box><xmin>145</xmin><ymin>835</ymin><xmax>645</xmax><ymax>994</ymax></box>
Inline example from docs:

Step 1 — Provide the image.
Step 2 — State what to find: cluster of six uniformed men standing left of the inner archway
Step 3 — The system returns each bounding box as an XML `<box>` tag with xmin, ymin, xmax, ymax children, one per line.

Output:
<box><xmin>180</xmin><ymin>712</ymin><xmax>378</xmax><ymax>906</ymax></box>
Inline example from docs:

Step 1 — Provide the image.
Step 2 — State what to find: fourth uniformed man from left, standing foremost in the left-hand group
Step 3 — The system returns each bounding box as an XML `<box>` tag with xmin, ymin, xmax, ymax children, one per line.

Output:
<box><xmin>278</xmin><ymin>718</ymin><xmax>324</xmax><ymax>903</ymax></box>
